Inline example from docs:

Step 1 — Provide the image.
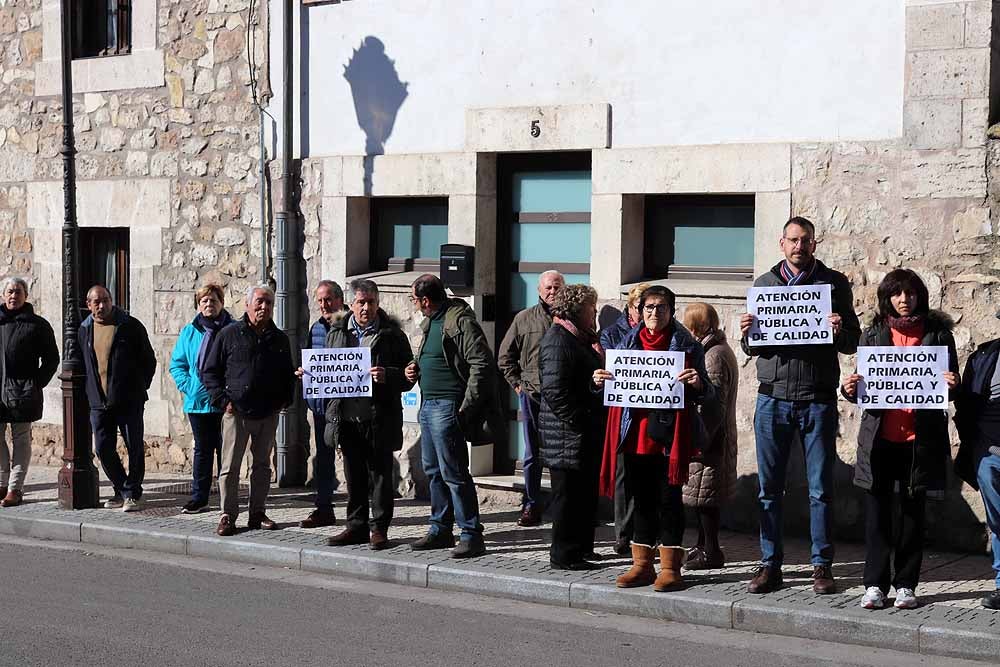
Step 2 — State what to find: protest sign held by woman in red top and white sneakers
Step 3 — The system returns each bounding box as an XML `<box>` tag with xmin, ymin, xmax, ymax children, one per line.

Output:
<box><xmin>858</xmin><ymin>345</ymin><xmax>948</xmax><ymax>410</ymax></box>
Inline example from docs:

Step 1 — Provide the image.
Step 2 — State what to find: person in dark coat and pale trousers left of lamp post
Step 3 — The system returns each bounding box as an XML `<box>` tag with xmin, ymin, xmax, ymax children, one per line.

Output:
<box><xmin>0</xmin><ymin>278</ymin><xmax>59</xmax><ymax>507</ymax></box>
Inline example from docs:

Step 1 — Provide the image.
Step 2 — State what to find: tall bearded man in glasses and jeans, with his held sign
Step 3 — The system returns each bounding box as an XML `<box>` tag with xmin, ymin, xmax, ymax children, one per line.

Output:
<box><xmin>740</xmin><ymin>217</ymin><xmax>861</xmax><ymax>594</ymax></box>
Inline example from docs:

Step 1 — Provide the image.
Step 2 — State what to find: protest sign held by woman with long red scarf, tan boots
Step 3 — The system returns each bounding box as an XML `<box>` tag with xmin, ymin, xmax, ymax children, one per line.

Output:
<box><xmin>604</xmin><ymin>350</ymin><xmax>684</xmax><ymax>410</ymax></box>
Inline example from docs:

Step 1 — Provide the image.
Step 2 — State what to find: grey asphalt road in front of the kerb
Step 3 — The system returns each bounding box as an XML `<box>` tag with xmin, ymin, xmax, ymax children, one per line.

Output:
<box><xmin>0</xmin><ymin>538</ymin><xmax>981</xmax><ymax>667</ymax></box>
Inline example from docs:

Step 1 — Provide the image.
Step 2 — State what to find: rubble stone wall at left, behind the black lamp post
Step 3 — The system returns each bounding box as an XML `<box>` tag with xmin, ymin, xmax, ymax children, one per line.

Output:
<box><xmin>0</xmin><ymin>0</ymin><xmax>267</xmax><ymax>471</ymax></box>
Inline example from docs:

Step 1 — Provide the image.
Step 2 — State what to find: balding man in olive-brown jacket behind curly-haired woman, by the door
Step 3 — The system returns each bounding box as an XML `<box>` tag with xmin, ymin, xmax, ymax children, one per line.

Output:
<box><xmin>497</xmin><ymin>271</ymin><xmax>566</xmax><ymax>526</ymax></box>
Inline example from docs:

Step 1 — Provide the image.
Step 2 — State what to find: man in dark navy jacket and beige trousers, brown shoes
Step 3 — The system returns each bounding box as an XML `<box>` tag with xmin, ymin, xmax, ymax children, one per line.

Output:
<box><xmin>201</xmin><ymin>285</ymin><xmax>295</xmax><ymax>537</ymax></box>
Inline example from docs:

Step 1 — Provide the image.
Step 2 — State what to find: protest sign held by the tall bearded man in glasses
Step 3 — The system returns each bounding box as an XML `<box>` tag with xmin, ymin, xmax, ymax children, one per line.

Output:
<box><xmin>747</xmin><ymin>285</ymin><xmax>833</xmax><ymax>346</ymax></box>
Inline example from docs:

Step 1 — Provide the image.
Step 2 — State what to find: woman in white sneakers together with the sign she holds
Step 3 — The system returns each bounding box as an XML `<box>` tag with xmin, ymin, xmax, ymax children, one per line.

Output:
<box><xmin>842</xmin><ymin>269</ymin><xmax>958</xmax><ymax>609</ymax></box>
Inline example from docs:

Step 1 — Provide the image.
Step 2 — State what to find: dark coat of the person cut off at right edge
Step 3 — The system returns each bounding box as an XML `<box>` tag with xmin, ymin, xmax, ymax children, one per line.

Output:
<box><xmin>955</xmin><ymin>338</ymin><xmax>1000</xmax><ymax>491</ymax></box>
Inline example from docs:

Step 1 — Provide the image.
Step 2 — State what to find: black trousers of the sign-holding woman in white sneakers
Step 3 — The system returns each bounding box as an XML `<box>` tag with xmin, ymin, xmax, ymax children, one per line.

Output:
<box><xmin>864</xmin><ymin>440</ymin><xmax>927</xmax><ymax>593</ymax></box>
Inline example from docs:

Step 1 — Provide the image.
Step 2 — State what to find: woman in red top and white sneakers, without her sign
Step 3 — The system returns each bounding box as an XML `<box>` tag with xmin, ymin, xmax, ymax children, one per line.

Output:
<box><xmin>841</xmin><ymin>269</ymin><xmax>959</xmax><ymax>609</ymax></box>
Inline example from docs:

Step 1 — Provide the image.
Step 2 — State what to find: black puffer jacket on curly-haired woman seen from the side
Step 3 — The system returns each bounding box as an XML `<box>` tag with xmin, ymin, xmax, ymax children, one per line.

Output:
<box><xmin>538</xmin><ymin>324</ymin><xmax>607</xmax><ymax>470</ymax></box>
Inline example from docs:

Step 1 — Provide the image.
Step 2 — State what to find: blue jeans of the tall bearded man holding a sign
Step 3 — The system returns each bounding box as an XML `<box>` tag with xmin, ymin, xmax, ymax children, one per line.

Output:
<box><xmin>753</xmin><ymin>394</ymin><xmax>838</xmax><ymax>567</ymax></box>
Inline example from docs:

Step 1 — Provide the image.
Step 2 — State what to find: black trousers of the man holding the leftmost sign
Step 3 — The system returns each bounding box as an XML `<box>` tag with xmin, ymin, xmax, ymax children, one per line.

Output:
<box><xmin>340</xmin><ymin>420</ymin><xmax>394</xmax><ymax>533</ymax></box>
